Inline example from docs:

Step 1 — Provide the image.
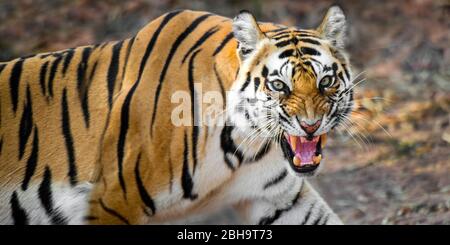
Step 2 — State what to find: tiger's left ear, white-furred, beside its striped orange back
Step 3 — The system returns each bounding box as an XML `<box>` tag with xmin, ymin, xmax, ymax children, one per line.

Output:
<box><xmin>233</xmin><ymin>10</ymin><xmax>265</xmax><ymax>60</ymax></box>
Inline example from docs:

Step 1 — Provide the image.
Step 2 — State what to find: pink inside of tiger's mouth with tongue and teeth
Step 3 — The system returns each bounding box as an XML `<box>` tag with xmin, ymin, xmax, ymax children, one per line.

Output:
<box><xmin>287</xmin><ymin>135</ymin><xmax>324</xmax><ymax>166</ymax></box>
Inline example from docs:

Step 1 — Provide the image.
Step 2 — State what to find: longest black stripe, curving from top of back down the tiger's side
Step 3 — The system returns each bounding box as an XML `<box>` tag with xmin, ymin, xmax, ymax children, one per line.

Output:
<box><xmin>117</xmin><ymin>11</ymin><xmax>182</xmax><ymax>199</ymax></box>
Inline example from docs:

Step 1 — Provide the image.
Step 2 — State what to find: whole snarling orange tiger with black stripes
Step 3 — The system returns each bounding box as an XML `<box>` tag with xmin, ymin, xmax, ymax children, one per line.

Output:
<box><xmin>0</xmin><ymin>6</ymin><xmax>354</xmax><ymax>225</ymax></box>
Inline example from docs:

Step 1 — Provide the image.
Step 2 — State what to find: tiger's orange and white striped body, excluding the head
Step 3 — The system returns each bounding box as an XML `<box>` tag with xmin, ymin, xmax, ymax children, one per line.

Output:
<box><xmin>0</xmin><ymin>7</ymin><xmax>350</xmax><ymax>224</ymax></box>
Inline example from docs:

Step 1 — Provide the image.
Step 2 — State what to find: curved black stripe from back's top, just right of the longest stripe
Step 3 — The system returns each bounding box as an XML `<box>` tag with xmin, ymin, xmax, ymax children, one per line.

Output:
<box><xmin>150</xmin><ymin>14</ymin><xmax>211</xmax><ymax>136</ymax></box>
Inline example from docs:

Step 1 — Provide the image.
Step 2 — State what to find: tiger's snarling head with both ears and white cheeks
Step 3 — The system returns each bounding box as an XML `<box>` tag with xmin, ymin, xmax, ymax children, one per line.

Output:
<box><xmin>229</xmin><ymin>7</ymin><xmax>353</xmax><ymax>176</ymax></box>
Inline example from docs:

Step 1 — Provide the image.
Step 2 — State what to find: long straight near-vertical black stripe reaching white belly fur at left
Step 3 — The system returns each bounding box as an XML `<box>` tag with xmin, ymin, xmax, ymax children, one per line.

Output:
<box><xmin>61</xmin><ymin>88</ymin><xmax>78</xmax><ymax>186</ymax></box>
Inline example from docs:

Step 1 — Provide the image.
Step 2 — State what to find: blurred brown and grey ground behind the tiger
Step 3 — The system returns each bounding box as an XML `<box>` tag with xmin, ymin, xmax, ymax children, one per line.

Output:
<box><xmin>0</xmin><ymin>0</ymin><xmax>450</xmax><ymax>224</ymax></box>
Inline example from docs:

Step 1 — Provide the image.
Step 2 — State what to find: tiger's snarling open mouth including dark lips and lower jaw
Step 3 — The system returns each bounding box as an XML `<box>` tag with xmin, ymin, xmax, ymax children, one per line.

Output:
<box><xmin>281</xmin><ymin>133</ymin><xmax>327</xmax><ymax>173</ymax></box>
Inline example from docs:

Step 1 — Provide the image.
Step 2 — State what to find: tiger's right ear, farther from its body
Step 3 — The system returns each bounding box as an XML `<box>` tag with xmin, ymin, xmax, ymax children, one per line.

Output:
<box><xmin>317</xmin><ymin>6</ymin><xmax>347</xmax><ymax>49</ymax></box>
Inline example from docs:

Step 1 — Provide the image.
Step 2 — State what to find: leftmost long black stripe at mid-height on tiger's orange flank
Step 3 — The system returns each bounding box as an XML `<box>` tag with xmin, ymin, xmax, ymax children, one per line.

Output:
<box><xmin>19</xmin><ymin>86</ymin><xmax>33</xmax><ymax>160</ymax></box>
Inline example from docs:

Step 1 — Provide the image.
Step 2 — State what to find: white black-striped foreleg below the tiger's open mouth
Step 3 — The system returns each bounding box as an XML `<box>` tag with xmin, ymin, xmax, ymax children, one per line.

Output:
<box><xmin>236</xmin><ymin>180</ymin><xmax>343</xmax><ymax>225</ymax></box>
